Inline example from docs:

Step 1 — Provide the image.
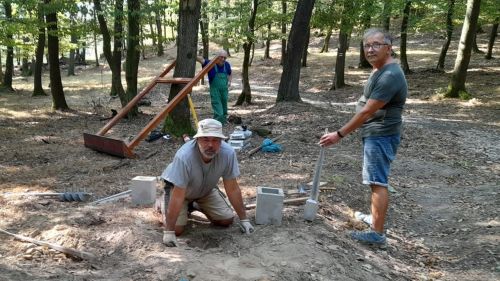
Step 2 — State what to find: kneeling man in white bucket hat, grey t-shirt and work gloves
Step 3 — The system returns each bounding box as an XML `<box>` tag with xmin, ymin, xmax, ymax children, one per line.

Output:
<box><xmin>161</xmin><ymin>119</ymin><xmax>254</xmax><ymax>247</ymax></box>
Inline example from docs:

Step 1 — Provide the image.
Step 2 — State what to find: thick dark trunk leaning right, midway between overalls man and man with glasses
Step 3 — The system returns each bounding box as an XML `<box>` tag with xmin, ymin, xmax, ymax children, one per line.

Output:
<box><xmin>276</xmin><ymin>0</ymin><xmax>315</xmax><ymax>102</ymax></box>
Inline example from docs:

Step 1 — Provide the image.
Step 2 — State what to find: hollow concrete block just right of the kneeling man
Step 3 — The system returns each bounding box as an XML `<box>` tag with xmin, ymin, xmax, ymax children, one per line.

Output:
<box><xmin>255</xmin><ymin>186</ymin><xmax>284</xmax><ymax>225</ymax></box>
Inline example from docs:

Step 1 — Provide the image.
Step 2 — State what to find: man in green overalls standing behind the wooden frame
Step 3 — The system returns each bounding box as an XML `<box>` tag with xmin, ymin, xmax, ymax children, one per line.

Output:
<box><xmin>197</xmin><ymin>50</ymin><xmax>232</xmax><ymax>124</ymax></box>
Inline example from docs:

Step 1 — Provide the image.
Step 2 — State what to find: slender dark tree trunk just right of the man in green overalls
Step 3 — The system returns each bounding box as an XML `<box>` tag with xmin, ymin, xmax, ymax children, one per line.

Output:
<box><xmin>236</xmin><ymin>0</ymin><xmax>259</xmax><ymax>105</ymax></box>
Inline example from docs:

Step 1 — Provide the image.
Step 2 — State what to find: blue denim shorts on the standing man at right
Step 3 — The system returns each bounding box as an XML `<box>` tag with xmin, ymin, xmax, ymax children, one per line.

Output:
<box><xmin>363</xmin><ymin>135</ymin><xmax>401</xmax><ymax>187</ymax></box>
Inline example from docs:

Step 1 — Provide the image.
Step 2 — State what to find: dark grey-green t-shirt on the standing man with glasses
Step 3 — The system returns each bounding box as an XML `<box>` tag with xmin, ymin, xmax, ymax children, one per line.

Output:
<box><xmin>356</xmin><ymin>63</ymin><xmax>408</xmax><ymax>137</ymax></box>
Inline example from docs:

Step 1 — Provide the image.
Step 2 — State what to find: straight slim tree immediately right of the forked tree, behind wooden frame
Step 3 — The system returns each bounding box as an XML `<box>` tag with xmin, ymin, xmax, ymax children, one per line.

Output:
<box><xmin>125</xmin><ymin>0</ymin><xmax>141</xmax><ymax>117</ymax></box>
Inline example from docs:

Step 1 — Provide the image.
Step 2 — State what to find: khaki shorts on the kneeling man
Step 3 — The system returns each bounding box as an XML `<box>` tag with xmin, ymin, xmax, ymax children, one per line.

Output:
<box><xmin>175</xmin><ymin>188</ymin><xmax>234</xmax><ymax>226</ymax></box>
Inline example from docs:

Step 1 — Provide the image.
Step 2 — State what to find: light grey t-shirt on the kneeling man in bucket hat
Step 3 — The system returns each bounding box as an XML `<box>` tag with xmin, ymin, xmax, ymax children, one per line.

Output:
<box><xmin>161</xmin><ymin>140</ymin><xmax>240</xmax><ymax>200</ymax></box>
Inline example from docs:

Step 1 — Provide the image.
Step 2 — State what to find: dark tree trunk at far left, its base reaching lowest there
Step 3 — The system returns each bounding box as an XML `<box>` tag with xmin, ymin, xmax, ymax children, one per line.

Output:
<box><xmin>45</xmin><ymin>0</ymin><xmax>69</xmax><ymax>111</ymax></box>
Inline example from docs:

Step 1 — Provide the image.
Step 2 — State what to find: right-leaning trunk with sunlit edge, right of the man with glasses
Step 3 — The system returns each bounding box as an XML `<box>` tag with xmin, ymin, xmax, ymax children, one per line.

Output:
<box><xmin>445</xmin><ymin>0</ymin><xmax>481</xmax><ymax>98</ymax></box>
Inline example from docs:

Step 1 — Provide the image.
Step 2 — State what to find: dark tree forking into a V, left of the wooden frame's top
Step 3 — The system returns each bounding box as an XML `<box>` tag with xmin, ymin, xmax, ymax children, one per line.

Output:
<box><xmin>94</xmin><ymin>0</ymin><xmax>128</xmax><ymax>107</ymax></box>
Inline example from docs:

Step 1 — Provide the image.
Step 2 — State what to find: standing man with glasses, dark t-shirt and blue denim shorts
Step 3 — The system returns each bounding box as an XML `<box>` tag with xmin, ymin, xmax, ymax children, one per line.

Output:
<box><xmin>319</xmin><ymin>28</ymin><xmax>408</xmax><ymax>246</ymax></box>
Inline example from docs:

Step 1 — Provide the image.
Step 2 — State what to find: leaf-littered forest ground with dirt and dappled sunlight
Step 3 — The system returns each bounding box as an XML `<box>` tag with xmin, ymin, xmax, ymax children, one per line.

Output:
<box><xmin>0</xmin><ymin>29</ymin><xmax>500</xmax><ymax>281</ymax></box>
